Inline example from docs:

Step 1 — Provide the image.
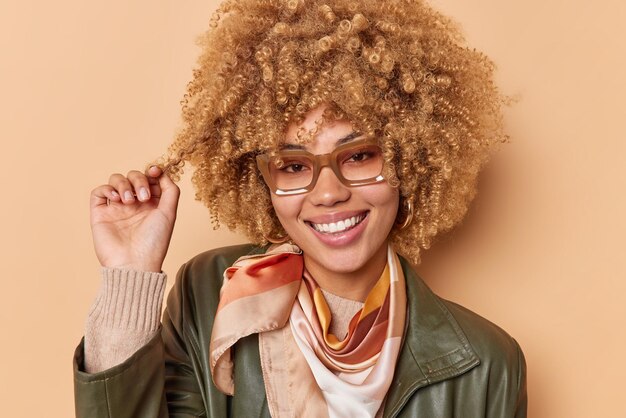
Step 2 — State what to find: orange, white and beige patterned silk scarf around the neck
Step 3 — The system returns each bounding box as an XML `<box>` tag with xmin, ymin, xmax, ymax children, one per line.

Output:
<box><xmin>210</xmin><ymin>244</ymin><xmax>406</xmax><ymax>418</ymax></box>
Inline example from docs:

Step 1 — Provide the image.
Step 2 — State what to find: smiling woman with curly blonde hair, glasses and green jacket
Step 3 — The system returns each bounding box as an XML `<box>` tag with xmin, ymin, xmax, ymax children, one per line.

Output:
<box><xmin>74</xmin><ymin>0</ymin><xmax>526</xmax><ymax>417</ymax></box>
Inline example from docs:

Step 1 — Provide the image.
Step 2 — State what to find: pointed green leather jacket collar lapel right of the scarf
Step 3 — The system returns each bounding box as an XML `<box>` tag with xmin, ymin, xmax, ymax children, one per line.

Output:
<box><xmin>384</xmin><ymin>257</ymin><xmax>480</xmax><ymax>417</ymax></box>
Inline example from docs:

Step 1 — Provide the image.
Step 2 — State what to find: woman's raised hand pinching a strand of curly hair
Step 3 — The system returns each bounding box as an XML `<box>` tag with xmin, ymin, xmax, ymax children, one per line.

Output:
<box><xmin>90</xmin><ymin>166</ymin><xmax>180</xmax><ymax>272</ymax></box>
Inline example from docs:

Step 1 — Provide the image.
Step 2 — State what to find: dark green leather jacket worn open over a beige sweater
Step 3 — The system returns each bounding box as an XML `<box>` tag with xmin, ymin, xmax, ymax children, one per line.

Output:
<box><xmin>74</xmin><ymin>245</ymin><xmax>527</xmax><ymax>418</ymax></box>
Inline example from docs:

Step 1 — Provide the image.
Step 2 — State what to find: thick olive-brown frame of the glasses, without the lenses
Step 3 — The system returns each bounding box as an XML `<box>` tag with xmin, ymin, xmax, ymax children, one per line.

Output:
<box><xmin>256</xmin><ymin>137</ymin><xmax>385</xmax><ymax>196</ymax></box>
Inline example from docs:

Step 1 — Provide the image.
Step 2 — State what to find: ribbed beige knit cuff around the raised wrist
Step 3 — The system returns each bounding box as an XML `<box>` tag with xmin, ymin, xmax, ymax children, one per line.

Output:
<box><xmin>88</xmin><ymin>267</ymin><xmax>167</xmax><ymax>332</ymax></box>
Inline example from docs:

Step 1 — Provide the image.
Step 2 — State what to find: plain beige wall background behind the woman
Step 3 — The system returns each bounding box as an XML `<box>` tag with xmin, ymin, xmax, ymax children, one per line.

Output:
<box><xmin>0</xmin><ymin>0</ymin><xmax>626</xmax><ymax>418</ymax></box>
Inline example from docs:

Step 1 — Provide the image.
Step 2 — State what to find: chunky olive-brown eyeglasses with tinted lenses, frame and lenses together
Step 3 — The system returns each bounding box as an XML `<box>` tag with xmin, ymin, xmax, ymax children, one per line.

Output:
<box><xmin>256</xmin><ymin>137</ymin><xmax>385</xmax><ymax>196</ymax></box>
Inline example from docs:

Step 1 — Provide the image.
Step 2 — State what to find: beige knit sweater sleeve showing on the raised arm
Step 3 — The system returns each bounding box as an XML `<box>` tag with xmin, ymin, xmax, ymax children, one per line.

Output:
<box><xmin>85</xmin><ymin>267</ymin><xmax>167</xmax><ymax>373</ymax></box>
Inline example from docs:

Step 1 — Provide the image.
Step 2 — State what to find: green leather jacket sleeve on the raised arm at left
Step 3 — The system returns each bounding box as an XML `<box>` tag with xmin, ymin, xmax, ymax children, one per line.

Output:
<box><xmin>74</xmin><ymin>265</ymin><xmax>227</xmax><ymax>418</ymax></box>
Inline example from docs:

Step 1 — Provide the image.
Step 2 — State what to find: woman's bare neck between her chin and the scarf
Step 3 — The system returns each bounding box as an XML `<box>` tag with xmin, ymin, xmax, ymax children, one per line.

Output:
<box><xmin>304</xmin><ymin>242</ymin><xmax>388</xmax><ymax>302</ymax></box>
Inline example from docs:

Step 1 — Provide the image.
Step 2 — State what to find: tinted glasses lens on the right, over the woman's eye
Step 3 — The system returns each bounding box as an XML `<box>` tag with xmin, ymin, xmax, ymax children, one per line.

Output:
<box><xmin>337</xmin><ymin>144</ymin><xmax>383</xmax><ymax>181</ymax></box>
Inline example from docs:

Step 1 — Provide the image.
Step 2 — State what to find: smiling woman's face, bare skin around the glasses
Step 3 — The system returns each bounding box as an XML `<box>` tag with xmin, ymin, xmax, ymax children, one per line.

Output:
<box><xmin>271</xmin><ymin>106</ymin><xmax>399</xmax><ymax>276</ymax></box>
